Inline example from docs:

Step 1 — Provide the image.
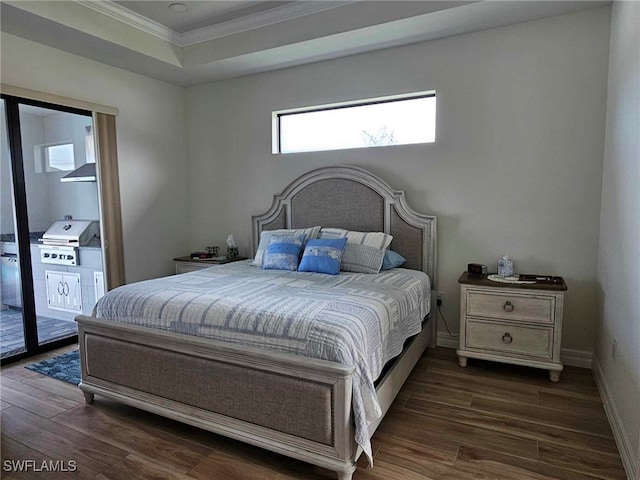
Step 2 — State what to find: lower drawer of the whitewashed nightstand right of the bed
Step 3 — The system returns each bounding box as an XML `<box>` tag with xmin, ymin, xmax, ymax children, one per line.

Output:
<box><xmin>465</xmin><ymin>319</ymin><xmax>553</xmax><ymax>359</ymax></box>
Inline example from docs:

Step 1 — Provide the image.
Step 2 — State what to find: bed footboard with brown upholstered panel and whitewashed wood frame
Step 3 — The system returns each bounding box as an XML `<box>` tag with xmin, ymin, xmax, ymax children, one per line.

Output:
<box><xmin>76</xmin><ymin>316</ymin><xmax>355</xmax><ymax>479</ymax></box>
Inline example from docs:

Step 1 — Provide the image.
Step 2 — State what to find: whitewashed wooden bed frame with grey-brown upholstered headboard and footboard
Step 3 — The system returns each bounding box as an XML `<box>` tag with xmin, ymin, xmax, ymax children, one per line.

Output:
<box><xmin>76</xmin><ymin>167</ymin><xmax>436</xmax><ymax>480</ymax></box>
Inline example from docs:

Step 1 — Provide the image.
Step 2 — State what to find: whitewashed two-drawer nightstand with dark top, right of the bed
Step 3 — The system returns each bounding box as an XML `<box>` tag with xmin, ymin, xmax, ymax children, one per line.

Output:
<box><xmin>457</xmin><ymin>272</ymin><xmax>567</xmax><ymax>382</ymax></box>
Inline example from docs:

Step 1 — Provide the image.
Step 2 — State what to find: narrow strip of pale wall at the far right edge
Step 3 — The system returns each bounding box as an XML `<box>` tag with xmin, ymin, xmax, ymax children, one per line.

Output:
<box><xmin>595</xmin><ymin>1</ymin><xmax>640</xmax><ymax>478</ymax></box>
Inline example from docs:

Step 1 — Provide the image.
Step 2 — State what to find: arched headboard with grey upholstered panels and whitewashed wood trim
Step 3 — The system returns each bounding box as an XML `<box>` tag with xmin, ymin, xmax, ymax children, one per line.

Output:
<box><xmin>252</xmin><ymin>166</ymin><xmax>436</xmax><ymax>289</ymax></box>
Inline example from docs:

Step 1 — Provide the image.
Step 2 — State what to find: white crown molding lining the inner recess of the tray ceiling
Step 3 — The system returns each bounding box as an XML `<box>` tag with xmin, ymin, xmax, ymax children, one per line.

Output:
<box><xmin>74</xmin><ymin>0</ymin><xmax>357</xmax><ymax>47</ymax></box>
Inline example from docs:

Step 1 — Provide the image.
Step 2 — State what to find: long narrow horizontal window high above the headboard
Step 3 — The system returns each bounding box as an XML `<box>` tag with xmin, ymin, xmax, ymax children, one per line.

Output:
<box><xmin>273</xmin><ymin>91</ymin><xmax>436</xmax><ymax>153</ymax></box>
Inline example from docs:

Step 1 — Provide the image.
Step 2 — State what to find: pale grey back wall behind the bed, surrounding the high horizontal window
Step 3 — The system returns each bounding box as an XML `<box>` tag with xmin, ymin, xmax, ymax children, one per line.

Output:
<box><xmin>187</xmin><ymin>8</ymin><xmax>609</xmax><ymax>352</ymax></box>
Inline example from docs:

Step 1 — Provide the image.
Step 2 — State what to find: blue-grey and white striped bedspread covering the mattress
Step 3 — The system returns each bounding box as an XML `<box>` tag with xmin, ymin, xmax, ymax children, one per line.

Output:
<box><xmin>93</xmin><ymin>260</ymin><xmax>431</xmax><ymax>458</ymax></box>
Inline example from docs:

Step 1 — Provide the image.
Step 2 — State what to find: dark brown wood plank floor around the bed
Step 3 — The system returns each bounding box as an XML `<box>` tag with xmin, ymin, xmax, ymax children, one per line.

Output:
<box><xmin>0</xmin><ymin>347</ymin><xmax>626</xmax><ymax>480</ymax></box>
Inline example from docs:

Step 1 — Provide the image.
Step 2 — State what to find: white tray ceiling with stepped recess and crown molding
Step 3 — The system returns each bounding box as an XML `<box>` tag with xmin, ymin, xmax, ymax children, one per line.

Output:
<box><xmin>0</xmin><ymin>0</ymin><xmax>610</xmax><ymax>86</ymax></box>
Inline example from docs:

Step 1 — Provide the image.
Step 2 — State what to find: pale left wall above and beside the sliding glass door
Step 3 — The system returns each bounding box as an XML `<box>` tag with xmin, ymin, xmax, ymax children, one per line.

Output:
<box><xmin>0</xmin><ymin>33</ymin><xmax>189</xmax><ymax>282</ymax></box>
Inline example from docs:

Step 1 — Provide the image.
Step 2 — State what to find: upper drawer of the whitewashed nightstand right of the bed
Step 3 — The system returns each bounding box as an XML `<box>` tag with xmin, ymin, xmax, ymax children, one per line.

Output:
<box><xmin>466</xmin><ymin>290</ymin><xmax>555</xmax><ymax>324</ymax></box>
